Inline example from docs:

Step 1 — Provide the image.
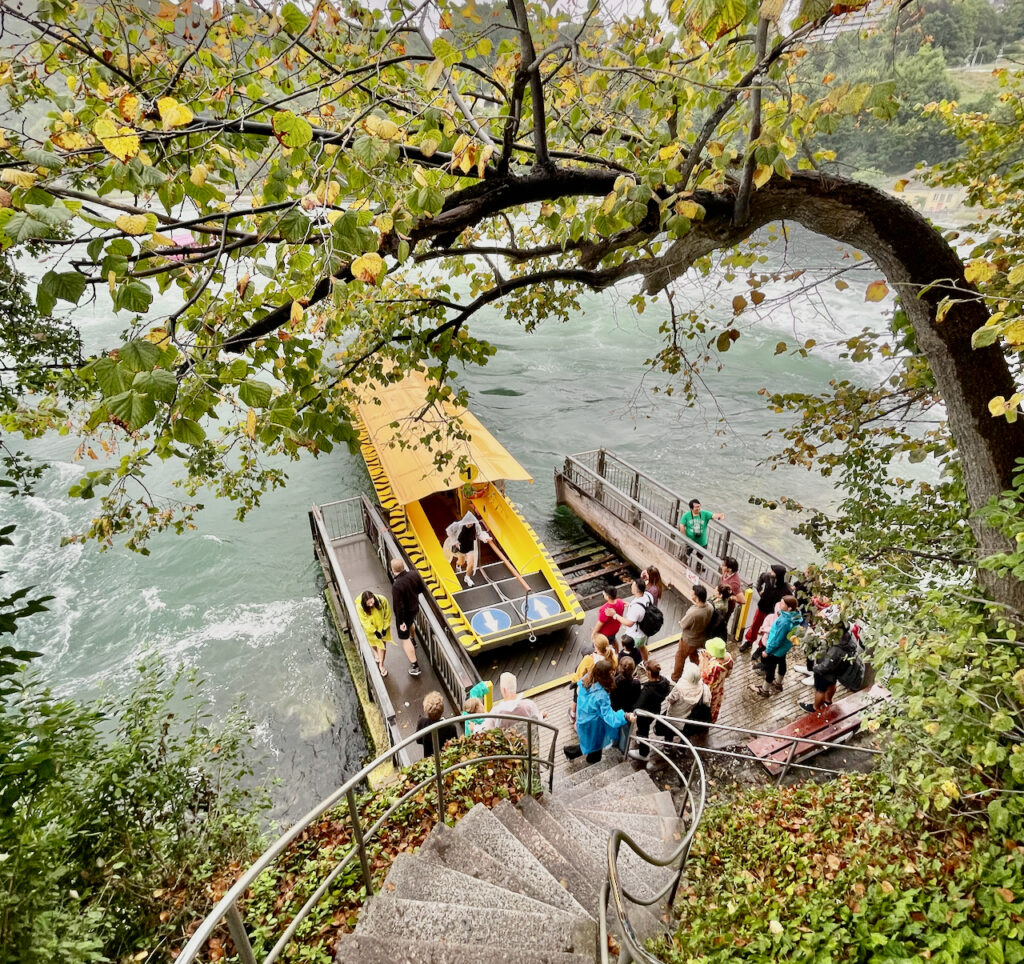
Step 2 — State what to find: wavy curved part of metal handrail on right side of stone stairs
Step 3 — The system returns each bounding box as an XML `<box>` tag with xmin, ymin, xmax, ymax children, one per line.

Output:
<box><xmin>598</xmin><ymin>710</ymin><xmax>708</xmax><ymax>964</ymax></box>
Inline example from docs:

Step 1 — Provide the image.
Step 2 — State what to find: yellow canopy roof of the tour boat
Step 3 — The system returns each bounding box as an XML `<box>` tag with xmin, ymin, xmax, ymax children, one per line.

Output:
<box><xmin>356</xmin><ymin>372</ymin><xmax>534</xmax><ymax>505</ymax></box>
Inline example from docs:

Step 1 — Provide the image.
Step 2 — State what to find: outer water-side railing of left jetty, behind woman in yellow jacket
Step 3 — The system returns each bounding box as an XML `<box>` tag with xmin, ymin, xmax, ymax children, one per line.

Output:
<box><xmin>309</xmin><ymin>496</ymin><xmax>401</xmax><ymax>765</ymax></box>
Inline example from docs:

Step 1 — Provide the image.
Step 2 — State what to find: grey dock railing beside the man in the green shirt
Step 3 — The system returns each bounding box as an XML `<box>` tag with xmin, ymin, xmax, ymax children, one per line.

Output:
<box><xmin>562</xmin><ymin>449</ymin><xmax>788</xmax><ymax>586</ymax></box>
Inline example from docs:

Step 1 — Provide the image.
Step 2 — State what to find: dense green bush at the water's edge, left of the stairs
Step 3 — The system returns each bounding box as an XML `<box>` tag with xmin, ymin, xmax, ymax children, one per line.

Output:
<box><xmin>0</xmin><ymin>664</ymin><xmax>265</xmax><ymax>964</ymax></box>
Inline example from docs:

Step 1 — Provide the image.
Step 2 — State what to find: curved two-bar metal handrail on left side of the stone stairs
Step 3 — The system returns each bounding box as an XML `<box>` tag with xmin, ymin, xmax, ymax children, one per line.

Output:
<box><xmin>174</xmin><ymin>712</ymin><xmax>559</xmax><ymax>964</ymax></box>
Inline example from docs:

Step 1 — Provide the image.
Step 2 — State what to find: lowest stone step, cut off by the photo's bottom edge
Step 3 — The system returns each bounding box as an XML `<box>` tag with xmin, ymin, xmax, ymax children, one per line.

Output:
<box><xmin>334</xmin><ymin>934</ymin><xmax>594</xmax><ymax>964</ymax></box>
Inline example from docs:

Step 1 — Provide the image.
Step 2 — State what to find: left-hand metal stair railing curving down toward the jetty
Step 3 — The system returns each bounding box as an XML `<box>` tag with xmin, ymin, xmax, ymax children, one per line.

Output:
<box><xmin>175</xmin><ymin>713</ymin><xmax>558</xmax><ymax>964</ymax></box>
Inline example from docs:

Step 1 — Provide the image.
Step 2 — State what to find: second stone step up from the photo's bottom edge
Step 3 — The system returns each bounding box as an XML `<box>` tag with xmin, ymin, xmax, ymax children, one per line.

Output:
<box><xmin>355</xmin><ymin>893</ymin><xmax>597</xmax><ymax>960</ymax></box>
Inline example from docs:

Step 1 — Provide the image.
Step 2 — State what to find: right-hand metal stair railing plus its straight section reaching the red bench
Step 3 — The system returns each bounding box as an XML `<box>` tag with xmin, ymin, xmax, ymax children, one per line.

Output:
<box><xmin>598</xmin><ymin>710</ymin><xmax>882</xmax><ymax>964</ymax></box>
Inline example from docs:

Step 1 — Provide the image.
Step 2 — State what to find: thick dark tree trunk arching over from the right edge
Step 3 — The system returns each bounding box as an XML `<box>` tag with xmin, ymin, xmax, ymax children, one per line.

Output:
<box><xmin>637</xmin><ymin>173</ymin><xmax>1024</xmax><ymax>613</ymax></box>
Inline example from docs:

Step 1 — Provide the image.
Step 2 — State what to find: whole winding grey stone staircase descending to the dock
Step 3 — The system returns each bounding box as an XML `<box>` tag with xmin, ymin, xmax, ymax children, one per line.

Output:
<box><xmin>336</xmin><ymin>750</ymin><xmax>680</xmax><ymax>964</ymax></box>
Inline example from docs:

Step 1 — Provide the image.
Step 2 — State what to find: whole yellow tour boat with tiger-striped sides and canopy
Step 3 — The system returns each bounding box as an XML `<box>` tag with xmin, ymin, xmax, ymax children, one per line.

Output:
<box><xmin>355</xmin><ymin>372</ymin><xmax>584</xmax><ymax>653</ymax></box>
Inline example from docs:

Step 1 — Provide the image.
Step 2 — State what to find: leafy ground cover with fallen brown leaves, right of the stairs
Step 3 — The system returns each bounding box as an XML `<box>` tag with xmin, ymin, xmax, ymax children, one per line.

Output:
<box><xmin>654</xmin><ymin>777</ymin><xmax>1024</xmax><ymax>964</ymax></box>
